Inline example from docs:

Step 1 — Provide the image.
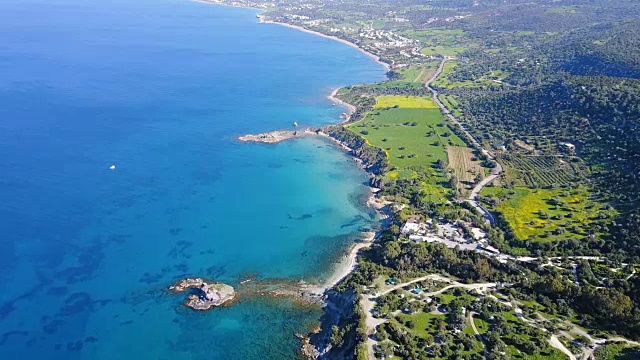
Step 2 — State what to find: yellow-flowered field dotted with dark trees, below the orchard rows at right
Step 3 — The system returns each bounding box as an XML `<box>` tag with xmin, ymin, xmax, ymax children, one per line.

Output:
<box><xmin>481</xmin><ymin>186</ymin><xmax>614</xmax><ymax>242</ymax></box>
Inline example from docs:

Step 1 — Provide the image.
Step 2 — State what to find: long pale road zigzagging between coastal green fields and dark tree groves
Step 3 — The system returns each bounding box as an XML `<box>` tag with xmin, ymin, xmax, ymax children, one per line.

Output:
<box><xmin>425</xmin><ymin>56</ymin><xmax>502</xmax><ymax>224</ymax></box>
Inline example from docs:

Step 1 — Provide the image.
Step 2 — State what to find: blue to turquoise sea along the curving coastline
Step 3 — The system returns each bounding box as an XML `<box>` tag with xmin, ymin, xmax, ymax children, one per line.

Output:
<box><xmin>0</xmin><ymin>0</ymin><xmax>384</xmax><ymax>360</ymax></box>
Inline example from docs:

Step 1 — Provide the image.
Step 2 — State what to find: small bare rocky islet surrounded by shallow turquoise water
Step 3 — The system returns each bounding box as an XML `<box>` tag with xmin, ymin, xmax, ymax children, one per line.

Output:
<box><xmin>169</xmin><ymin>278</ymin><xmax>236</xmax><ymax>310</ymax></box>
